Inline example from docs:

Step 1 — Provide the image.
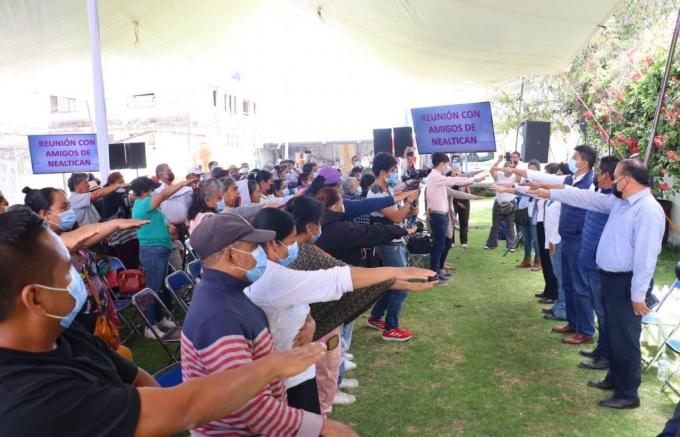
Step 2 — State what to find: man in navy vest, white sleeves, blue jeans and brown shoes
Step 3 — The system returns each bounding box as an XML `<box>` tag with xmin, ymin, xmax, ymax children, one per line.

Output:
<box><xmin>513</xmin><ymin>144</ymin><xmax>597</xmax><ymax>345</ymax></box>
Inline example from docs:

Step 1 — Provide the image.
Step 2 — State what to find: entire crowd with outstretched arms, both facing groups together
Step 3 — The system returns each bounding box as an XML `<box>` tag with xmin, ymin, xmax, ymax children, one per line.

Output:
<box><xmin>0</xmin><ymin>145</ymin><xmax>664</xmax><ymax>436</ymax></box>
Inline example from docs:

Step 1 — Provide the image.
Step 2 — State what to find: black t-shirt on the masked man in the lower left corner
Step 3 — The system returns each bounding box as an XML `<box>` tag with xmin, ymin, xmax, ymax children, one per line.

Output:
<box><xmin>0</xmin><ymin>322</ymin><xmax>140</xmax><ymax>437</ymax></box>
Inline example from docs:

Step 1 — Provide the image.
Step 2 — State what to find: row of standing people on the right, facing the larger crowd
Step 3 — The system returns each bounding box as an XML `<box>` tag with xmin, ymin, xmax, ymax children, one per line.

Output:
<box><xmin>486</xmin><ymin>145</ymin><xmax>665</xmax><ymax>409</ymax></box>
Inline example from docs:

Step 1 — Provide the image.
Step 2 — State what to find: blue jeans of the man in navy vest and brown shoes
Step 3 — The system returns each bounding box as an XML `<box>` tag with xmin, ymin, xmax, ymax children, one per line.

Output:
<box><xmin>562</xmin><ymin>239</ymin><xmax>595</xmax><ymax>337</ymax></box>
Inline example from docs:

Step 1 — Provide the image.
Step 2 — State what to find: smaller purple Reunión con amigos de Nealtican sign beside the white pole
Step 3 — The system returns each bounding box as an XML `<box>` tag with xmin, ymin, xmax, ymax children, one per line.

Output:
<box><xmin>28</xmin><ymin>134</ymin><xmax>99</xmax><ymax>174</ymax></box>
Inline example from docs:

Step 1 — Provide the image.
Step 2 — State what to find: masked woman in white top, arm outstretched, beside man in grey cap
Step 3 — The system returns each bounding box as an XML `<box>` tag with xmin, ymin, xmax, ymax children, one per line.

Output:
<box><xmin>245</xmin><ymin>208</ymin><xmax>431</xmax><ymax>412</ymax></box>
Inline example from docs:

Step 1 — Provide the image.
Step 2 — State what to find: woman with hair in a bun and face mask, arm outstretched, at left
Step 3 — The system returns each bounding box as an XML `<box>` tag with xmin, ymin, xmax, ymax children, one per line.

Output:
<box><xmin>23</xmin><ymin>187</ymin><xmax>146</xmax><ymax>349</ymax></box>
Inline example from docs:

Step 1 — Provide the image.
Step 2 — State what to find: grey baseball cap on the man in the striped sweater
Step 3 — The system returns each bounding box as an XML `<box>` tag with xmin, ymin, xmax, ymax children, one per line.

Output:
<box><xmin>191</xmin><ymin>213</ymin><xmax>276</xmax><ymax>258</ymax></box>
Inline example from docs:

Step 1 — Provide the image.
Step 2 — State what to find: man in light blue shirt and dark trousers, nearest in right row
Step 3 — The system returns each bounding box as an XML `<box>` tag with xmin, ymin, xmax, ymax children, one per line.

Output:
<box><xmin>529</xmin><ymin>159</ymin><xmax>665</xmax><ymax>409</ymax></box>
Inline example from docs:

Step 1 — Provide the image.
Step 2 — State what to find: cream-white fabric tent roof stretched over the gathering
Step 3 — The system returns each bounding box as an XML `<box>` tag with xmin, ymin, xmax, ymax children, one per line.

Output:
<box><xmin>0</xmin><ymin>0</ymin><xmax>618</xmax><ymax>85</ymax></box>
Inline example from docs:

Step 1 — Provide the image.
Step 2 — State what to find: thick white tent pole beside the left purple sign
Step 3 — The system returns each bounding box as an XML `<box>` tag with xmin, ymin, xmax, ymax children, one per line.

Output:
<box><xmin>87</xmin><ymin>0</ymin><xmax>111</xmax><ymax>180</ymax></box>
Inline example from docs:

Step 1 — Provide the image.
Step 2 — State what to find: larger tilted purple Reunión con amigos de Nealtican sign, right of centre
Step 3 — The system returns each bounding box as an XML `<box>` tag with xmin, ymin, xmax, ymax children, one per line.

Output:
<box><xmin>411</xmin><ymin>102</ymin><xmax>496</xmax><ymax>154</ymax></box>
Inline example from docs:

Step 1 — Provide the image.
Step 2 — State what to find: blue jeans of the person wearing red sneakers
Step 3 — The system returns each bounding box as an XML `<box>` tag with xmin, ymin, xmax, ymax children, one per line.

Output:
<box><xmin>371</xmin><ymin>243</ymin><xmax>408</xmax><ymax>331</ymax></box>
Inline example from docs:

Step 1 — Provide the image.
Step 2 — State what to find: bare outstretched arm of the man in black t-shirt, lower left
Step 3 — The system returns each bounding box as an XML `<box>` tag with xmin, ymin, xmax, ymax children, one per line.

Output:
<box><xmin>135</xmin><ymin>343</ymin><xmax>326</xmax><ymax>436</ymax></box>
